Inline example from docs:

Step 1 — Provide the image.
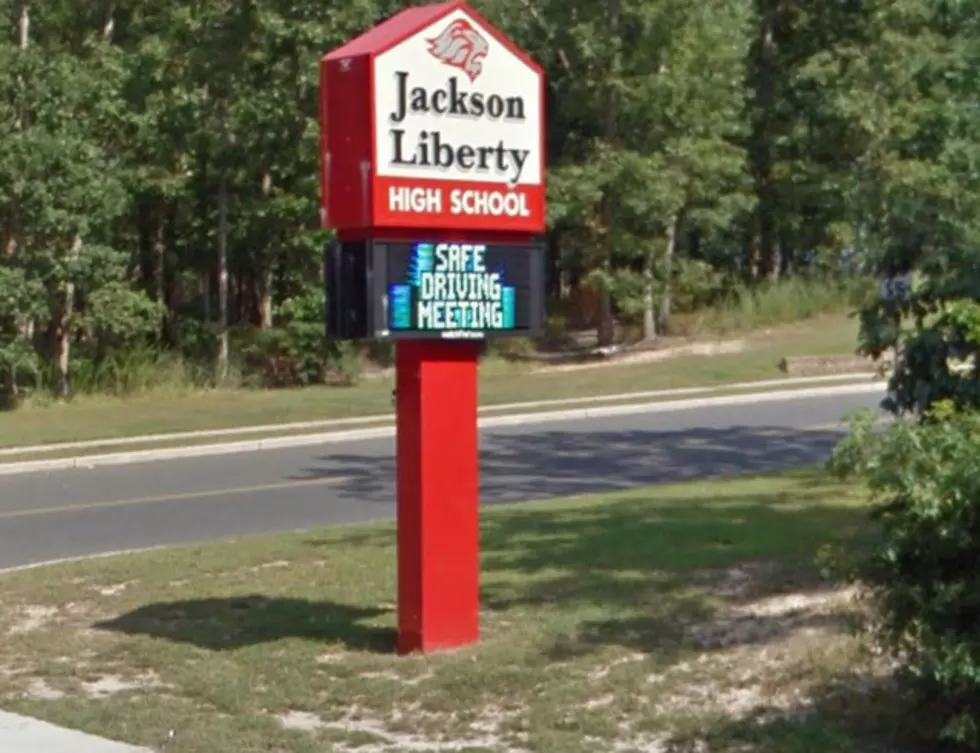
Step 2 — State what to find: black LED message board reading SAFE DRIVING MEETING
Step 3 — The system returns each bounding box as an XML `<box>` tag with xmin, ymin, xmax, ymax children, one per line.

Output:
<box><xmin>326</xmin><ymin>240</ymin><xmax>545</xmax><ymax>340</ymax></box>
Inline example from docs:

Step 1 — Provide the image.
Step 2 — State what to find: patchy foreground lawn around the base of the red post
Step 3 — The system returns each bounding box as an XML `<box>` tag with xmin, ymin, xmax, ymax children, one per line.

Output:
<box><xmin>0</xmin><ymin>470</ymin><xmax>912</xmax><ymax>753</ymax></box>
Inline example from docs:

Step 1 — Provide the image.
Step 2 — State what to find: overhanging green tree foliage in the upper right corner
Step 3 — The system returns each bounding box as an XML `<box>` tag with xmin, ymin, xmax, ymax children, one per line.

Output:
<box><xmin>846</xmin><ymin>0</ymin><xmax>980</xmax><ymax>413</ymax></box>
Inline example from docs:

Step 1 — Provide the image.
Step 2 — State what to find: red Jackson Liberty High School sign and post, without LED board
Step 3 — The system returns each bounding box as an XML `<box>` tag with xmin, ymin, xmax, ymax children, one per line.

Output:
<box><xmin>320</xmin><ymin>1</ymin><xmax>546</xmax><ymax>654</ymax></box>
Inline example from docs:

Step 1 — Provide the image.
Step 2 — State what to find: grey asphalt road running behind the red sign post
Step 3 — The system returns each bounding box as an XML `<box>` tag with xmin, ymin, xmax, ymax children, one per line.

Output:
<box><xmin>0</xmin><ymin>394</ymin><xmax>880</xmax><ymax>569</ymax></box>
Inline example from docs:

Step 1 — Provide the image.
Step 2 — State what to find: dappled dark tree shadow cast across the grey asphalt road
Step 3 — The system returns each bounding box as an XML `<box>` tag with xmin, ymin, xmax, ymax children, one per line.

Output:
<box><xmin>289</xmin><ymin>426</ymin><xmax>843</xmax><ymax>503</ymax></box>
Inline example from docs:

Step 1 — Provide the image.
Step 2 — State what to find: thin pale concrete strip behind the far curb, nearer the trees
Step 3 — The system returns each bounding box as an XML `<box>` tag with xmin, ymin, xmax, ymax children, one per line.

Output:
<box><xmin>0</xmin><ymin>372</ymin><xmax>871</xmax><ymax>458</ymax></box>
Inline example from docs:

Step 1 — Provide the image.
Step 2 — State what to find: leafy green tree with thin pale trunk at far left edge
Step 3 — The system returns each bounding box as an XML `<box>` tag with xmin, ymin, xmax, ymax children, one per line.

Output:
<box><xmin>0</xmin><ymin>1</ymin><xmax>149</xmax><ymax>397</ymax></box>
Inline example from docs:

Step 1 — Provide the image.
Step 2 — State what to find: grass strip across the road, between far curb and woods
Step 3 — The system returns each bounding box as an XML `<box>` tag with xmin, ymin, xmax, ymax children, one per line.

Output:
<box><xmin>0</xmin><ymin>316</ymin><xmax>857</xmax><ymax>447</ymax></box>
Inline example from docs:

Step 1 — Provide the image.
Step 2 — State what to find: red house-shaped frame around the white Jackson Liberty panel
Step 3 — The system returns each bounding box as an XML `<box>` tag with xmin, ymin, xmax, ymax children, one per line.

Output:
<box><xmin>320</xmin><ymin>2</ymin><xmax>546</xmax><ymax>235</ymax></box>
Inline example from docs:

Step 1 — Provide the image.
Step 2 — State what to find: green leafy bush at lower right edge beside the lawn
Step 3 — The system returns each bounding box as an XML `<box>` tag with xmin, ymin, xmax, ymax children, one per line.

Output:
<box><xmin>831</xmin><ymin>403</ymin><xmax>980</xmax><ymax>750</ymax></box>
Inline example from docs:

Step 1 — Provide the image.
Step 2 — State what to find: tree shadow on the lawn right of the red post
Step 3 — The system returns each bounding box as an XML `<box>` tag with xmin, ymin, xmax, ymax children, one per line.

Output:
<box><xmin>482</xmin><ymin>469</ymin><xmax>867</xmax><ymax>652</ymax></box>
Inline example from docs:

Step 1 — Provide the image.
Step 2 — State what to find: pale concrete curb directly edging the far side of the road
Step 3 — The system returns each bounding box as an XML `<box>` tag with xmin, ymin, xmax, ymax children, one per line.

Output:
<box><xmin>0</xmin><ymin>381</ymin><xmax>887</xmax><ymax>475</ymax></box>
